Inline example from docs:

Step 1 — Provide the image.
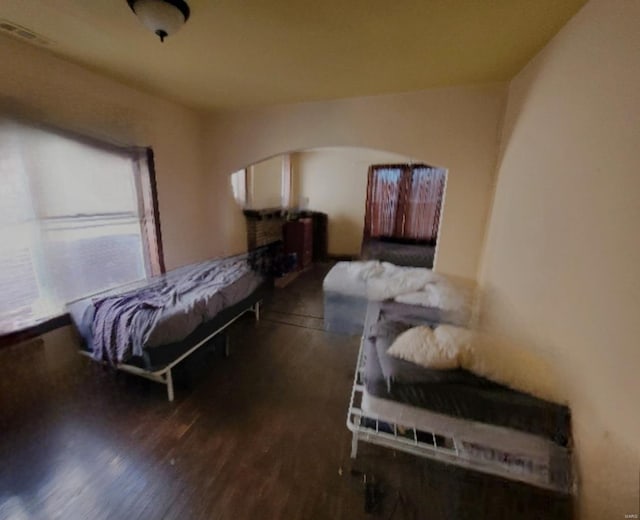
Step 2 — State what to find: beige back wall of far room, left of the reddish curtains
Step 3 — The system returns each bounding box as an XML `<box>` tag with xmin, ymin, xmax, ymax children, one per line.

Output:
<box><xmin>294</xmin><ymin>148</ymin><xmax>411</xmax><ymax>255</ymax></box>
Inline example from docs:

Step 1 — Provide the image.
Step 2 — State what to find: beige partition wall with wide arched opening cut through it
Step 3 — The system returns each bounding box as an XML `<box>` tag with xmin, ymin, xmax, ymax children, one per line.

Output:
<box><xmin>206</xmin><ymin>85</ymin><xmax>506</xmax><ymax>278</ymax></box>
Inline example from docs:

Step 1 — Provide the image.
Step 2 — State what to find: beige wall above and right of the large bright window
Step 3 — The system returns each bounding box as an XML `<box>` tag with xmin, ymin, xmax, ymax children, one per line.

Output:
<box><xmin>0</xmin><ymin>36</ymin><xmax>212</xmax><ymax>268</ymax></box>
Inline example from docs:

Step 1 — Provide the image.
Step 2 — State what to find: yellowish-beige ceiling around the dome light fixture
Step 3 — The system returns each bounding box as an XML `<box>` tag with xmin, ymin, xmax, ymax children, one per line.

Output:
<box><xmin>0</xmin><ymin>0</ymin><xmax>585</xmax><ymax>110</ymax></box>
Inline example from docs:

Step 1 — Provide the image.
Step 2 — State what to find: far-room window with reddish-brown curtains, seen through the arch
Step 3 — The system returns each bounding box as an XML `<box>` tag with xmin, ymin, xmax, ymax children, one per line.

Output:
<box><xmin>364</xmin><ymin>164</ymin><xmax>446</xmax><ymax>243</ymax></box>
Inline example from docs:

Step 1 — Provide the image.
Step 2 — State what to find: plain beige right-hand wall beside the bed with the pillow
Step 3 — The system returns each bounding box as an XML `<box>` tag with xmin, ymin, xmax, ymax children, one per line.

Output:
<box><xmin>480</xmin><ymin>0</ymin><xmax>640</xmax><ymax>520</ymax></box>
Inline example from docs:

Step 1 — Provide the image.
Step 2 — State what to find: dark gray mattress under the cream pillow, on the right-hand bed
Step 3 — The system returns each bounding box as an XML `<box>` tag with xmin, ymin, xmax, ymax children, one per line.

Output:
<box><xmin>365</xmin><ymin>309</ymin><xmax>571</xmax><ymax>446</ymax></box>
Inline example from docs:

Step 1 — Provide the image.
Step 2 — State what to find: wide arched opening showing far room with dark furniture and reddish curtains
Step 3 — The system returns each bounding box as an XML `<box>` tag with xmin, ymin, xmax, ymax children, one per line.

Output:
<box><xmin>231</xmin><ymin>147</ymin><xmax>447</xmax><ymax>268</ymax></box>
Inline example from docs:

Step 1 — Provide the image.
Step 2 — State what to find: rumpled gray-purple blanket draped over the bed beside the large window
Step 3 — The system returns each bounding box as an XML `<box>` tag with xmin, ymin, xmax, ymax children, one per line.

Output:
<box><xmin>91</xmin><ymin>257</ymin><xmax>255</xmax><ymax>365</ymax></box>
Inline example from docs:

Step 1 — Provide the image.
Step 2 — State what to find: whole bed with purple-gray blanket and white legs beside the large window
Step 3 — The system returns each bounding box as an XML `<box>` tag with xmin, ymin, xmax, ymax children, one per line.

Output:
<box><xmin>68</xmin><ymin>255</ymin><xmax>268</xmax><ymax>401</ymax></box>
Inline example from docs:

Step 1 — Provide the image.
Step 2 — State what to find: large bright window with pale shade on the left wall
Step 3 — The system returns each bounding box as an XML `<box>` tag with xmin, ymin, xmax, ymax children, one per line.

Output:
<box><xmin>0</xmin><ymin>121</ymin><xmax>162</xmax><ymax>334</ymax></box>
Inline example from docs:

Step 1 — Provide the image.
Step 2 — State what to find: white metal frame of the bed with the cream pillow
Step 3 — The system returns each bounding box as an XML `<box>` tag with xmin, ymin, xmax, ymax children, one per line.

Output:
<box><xmin>347</xmin><ymin>338</ymin><xmax>577</xmax><ymax>493</ymax></box>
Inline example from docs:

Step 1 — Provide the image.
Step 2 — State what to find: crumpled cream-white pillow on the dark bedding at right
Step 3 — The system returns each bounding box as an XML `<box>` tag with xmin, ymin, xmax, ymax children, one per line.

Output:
<box><xmin>387</xmin><ymin>325</ymin><xmax>471</xmax><ymax>370</ymax></box>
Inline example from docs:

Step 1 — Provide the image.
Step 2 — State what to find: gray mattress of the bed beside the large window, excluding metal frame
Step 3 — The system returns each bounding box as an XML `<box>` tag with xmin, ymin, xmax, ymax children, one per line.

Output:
<box><xmin>68</xmin><ymin>257</ymin><xmax>264</xmax><ymax>362</ymax></box>
